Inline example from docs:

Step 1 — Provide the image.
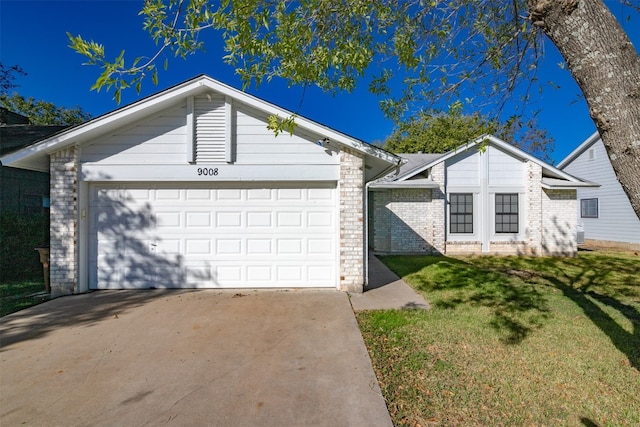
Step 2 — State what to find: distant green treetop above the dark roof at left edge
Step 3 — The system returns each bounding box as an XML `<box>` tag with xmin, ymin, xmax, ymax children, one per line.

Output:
<box><xmin>0</xmin><ymin>93</ymin><xmax>91</xmax><ymax>125</ymax></box>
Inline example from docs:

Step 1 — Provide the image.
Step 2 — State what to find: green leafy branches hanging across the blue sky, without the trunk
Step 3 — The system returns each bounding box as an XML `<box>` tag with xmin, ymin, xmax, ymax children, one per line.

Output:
<box><xmin>68</xmin><ymin>0</ymin><xmax>540</xmax><ymax>120</ymax></box>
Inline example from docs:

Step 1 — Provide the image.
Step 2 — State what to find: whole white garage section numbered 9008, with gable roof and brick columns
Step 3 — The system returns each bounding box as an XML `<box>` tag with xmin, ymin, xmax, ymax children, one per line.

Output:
<box><xmin>2</xmin><ymin>76</ymin><xmax>401</xmax><ymax>296</ymax></box>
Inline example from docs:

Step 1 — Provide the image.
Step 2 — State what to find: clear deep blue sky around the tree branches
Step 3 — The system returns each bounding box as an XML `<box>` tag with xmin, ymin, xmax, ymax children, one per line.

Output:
<box><xmin>0</xmin><ymin>0</ymin><xmax>640</xmax><ymax>162</ymax></box>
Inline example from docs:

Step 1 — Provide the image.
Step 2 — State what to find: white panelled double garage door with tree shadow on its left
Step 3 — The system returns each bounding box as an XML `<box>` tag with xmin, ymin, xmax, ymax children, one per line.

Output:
<box><xmin>89</xmin><ymin>183</ymin><xmax>338</xmax><ymax>289</ymax></box>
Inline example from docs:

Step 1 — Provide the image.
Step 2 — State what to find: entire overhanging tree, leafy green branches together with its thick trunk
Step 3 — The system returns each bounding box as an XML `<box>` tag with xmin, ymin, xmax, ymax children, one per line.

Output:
<box><xmin>69</xmin><ymin>0</ymin><xmax>640</xmax><ymax>217</ymax></box>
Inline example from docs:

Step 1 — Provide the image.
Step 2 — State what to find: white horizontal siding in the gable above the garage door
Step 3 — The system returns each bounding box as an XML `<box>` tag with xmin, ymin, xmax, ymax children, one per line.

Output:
<box><xmin>80</xmin><ymin>92</ymin><xmax>339</xmax><ymax>181</ymax></box>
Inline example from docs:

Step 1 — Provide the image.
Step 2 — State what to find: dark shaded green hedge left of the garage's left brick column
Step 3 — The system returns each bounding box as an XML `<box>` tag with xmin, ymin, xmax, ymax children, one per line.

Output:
<box><xmin>0</xmin><ymin>211</ymin><xmax>49</xmax><ymax>283</ymax></box>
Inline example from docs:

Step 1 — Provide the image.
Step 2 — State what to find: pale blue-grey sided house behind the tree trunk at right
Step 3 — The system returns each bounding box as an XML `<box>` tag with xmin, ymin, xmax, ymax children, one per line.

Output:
<box><xmin>558</xmin><ymin>132</ymin><xmax>640</xmax><ymax>249</ymax></box>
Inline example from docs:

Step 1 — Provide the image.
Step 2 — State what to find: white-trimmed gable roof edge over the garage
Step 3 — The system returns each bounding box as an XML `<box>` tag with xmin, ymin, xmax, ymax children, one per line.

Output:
<box><xmin>0</xmin><ymin>75</ymin><xmax>401</xmax><ymax>171</ymax></box>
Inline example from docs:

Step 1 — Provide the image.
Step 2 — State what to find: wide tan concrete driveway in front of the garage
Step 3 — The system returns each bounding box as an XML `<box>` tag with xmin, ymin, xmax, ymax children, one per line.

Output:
<box><xmin>0</xmin><ymin>290</ymin><xmax>391</xmax><ymax>426</ymax></box>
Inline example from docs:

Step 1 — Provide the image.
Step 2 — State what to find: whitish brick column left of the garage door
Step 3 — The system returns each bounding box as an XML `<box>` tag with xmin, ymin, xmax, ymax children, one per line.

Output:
<box><xmin>49</xmin><ymin>147</ymin><xmax>78</xmax><ymax>297</ymax></box>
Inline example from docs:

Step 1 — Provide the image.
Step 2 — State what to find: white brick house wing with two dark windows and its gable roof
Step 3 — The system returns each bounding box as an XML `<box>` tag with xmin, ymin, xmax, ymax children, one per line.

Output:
<box><xmin>368</xmin><ymin>136</ymin><xmax>595</xmax><ymax>255</ymax></box>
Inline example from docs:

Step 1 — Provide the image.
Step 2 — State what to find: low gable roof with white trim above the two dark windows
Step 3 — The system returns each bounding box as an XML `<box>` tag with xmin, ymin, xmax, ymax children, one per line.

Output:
<box><xmin>372</xmin><ymin>135</ymin><xmax>599</xmax><ymax>189</ymax></box>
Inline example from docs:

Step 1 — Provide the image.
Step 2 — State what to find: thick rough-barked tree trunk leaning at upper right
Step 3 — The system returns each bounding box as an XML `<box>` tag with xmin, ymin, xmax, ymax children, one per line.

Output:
<box><xmin>527</xmin><ymin>0</ymin><xmax>640</xmax><ymax>218</ymax></box>
